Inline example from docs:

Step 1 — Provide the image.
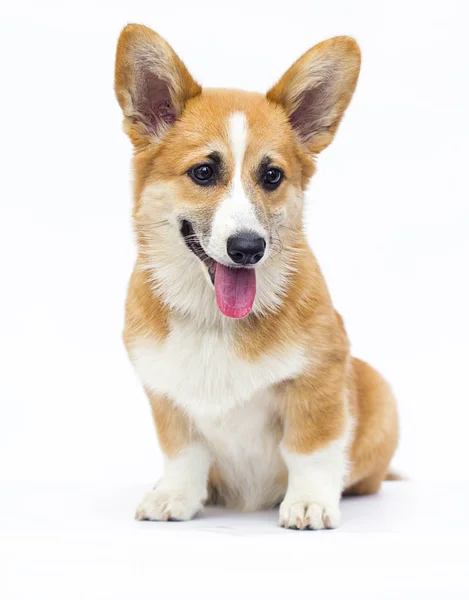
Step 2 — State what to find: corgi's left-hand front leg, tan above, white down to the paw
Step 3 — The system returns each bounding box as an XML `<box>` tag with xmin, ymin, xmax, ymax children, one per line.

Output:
<box><xmin>135</xmin><ymin>392</ymin><xmax>211</xmax><ymax>521</ymax></box>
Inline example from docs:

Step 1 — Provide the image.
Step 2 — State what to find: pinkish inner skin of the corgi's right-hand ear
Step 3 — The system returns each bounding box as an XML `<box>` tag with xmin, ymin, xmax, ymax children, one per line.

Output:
<box><xmin>290</xmin><ymin>74</ymin><xmax>334</xmax><ymax>141</ymax></box>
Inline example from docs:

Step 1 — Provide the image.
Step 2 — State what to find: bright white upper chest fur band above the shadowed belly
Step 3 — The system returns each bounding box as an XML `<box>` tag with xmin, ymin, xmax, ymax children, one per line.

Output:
<box><xmin>130</xmin><ymin>322</ymin><xmax>305</xmax><ymax>419</ymax></box>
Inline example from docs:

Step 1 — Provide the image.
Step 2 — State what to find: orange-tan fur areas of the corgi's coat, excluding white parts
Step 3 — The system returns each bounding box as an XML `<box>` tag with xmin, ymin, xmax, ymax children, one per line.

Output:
<box><xmin>115</xmin><ymin>25</ymin><xmax>398</xmax><ymax>516</ymax></box>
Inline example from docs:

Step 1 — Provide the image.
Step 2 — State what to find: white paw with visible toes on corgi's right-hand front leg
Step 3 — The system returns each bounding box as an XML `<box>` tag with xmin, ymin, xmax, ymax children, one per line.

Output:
<box><xmin>279</xmin><ymin>498</ymin><xmax>340</xmax><ymax>529</ymax></box>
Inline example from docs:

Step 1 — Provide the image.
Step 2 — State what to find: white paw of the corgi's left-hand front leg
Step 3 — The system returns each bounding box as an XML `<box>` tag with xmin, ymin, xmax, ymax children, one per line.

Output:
<box><xmin>135</xmin><ymin>485</ymin><xmax>203</xmax><ymax>521</ymax></box>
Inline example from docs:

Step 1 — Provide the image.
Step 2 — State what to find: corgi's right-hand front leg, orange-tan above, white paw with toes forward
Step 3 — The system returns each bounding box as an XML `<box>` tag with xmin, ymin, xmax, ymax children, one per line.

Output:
<box><xmin>279</xmin><ymin>365</ymin><xmax>349</xmax><ymax>529</ymax></box>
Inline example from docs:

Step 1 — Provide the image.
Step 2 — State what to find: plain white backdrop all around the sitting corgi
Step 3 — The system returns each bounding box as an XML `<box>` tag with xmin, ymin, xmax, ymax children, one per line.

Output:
<box><xmin>0</xmin><ymin>0</ymin><xmax>469</xmax><ymax>600</ymax></box>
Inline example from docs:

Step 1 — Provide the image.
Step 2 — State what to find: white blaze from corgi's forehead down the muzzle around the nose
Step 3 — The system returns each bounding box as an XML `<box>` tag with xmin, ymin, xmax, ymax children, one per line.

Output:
<box><xmin>208</xmin><ymin>111</ymin><xmax>266</xmax><ymax>262</ymax></box>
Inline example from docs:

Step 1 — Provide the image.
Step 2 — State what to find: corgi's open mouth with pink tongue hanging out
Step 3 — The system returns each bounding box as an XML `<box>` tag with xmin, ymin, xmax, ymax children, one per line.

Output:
<box><xmin>180</xmin><ymin>220</ymin><xmax>256</xmax><ymax>319</ymax></box>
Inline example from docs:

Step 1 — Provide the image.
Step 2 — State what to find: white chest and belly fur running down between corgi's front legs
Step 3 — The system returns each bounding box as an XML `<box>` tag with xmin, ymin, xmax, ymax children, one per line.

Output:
<box><xmin>130</xmin><ymin>316</ymin><xmax>305</xmax><ymax>510</ymax></box>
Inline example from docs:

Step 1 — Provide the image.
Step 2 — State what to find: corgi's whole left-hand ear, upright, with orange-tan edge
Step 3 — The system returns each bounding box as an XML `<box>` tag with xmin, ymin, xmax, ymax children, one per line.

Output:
<box><xmin>114</xmin><ymin>25</ymin><xmax>202</xmax><ymax>147</ymax></box>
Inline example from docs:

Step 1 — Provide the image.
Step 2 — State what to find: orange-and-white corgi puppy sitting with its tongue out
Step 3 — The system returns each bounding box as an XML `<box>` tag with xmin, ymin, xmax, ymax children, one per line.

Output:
<box><xmin>115</xmin><ymin>25</ymin><xmax>398</xmax><ymax>530</ymax></box>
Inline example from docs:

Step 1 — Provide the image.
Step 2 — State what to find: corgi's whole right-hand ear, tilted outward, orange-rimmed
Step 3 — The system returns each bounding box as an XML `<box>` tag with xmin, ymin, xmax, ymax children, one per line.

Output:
<box><xmin>267</xmin><ymin>36</ymin><xmax>360</xmax><ymax>154</ymax></box>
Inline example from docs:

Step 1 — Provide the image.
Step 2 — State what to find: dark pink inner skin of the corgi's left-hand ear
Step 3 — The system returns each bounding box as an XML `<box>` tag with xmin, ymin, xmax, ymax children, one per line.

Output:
<box><xmin>134</xmin><ymin>68</ymin><xmax>177</xmax><ymax>133</ymax></box>
